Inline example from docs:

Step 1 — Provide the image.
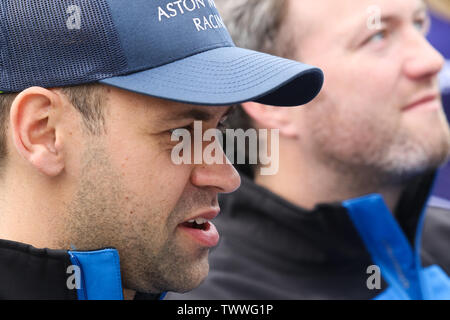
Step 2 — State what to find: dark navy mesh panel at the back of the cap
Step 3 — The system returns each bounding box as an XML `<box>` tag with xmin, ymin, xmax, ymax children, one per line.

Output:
<box><xmin>0</xmin><ymin>0</ymin><xmax>127</xmax><ymax>92</ymax></box>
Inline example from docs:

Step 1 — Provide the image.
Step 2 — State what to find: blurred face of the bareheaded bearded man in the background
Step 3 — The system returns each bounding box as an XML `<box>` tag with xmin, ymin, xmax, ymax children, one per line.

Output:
<box><xmin>284</xmin><ymin>0</ymin><xmax>450</xmax><ymax>179</ymax></box>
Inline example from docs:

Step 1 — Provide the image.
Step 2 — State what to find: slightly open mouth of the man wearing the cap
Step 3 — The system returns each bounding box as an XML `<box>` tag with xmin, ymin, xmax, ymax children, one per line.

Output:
<box><xmin>178</xmin><ymin>210</ymin><xmax>219</xmax><ymax>248</ymax></box>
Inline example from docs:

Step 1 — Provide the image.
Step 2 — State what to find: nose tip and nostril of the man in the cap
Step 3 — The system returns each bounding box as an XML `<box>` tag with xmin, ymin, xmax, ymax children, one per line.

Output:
<box><xmin>191</xmin><ymin>151</ymin><xmax>241</xmax><ymax>193</ymax></box>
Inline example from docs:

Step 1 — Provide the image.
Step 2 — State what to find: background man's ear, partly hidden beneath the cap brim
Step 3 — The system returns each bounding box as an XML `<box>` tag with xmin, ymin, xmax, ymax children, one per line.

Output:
<box><xmin>242</xmin><ymin>102</ymin><xmax>298</xmax><ymax>138</ymax></box>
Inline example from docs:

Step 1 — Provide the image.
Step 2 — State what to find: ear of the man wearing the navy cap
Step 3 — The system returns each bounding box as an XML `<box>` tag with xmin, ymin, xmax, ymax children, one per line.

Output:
<box><xmin>10</xmin><ymin>87</ymin><xmax>64</xmax><ymax>177</ymax></box>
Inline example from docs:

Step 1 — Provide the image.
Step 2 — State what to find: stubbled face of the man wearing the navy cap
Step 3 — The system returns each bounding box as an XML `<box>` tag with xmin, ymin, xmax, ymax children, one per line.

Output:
<box><xmin>62</xmin><ymin>89</ymin><xmax>240</xmax><ymax>292</ymax></box>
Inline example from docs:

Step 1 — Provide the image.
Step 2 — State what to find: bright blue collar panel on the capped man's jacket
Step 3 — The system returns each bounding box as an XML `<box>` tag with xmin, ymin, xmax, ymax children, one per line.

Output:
<box><xmin>68</xmin><ymin>249</ymin><xmax>123</xmax><ymax>300</ymax></box>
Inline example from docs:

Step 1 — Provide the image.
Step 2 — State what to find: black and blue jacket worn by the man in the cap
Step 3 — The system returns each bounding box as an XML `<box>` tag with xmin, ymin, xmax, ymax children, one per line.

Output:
<box><xmin>0</xmin><ymin>240</ymin><xmax>163</xmax><ymax>300</ymax></box>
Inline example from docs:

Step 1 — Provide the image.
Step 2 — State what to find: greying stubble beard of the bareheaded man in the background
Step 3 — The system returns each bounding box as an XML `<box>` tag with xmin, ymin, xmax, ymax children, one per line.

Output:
<box><xmin>312</xmin><ymin>104</ymin><xmax>450</xmax><ymax>192</ymax></box>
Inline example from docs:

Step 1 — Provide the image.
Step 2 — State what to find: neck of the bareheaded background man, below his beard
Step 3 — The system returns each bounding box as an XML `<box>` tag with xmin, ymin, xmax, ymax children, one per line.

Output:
<box><xmin>255</xmin><ymin>144</ymin><xmax>403</xmax><ymax>212</ymax></box>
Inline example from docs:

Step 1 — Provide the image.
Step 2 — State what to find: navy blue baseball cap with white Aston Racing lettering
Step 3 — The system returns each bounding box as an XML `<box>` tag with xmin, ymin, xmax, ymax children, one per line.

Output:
<box><xmin>0</xmin><ymin>0</ymin><xmax>323</xmax><ymax>106</ymax></box>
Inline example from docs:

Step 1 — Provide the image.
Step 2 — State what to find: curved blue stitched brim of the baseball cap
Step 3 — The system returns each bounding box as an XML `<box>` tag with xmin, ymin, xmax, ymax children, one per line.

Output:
<box><xmin>100</xmin><ymin>47</ymin><xmax>323</xmax><ymax>106</ymax></box>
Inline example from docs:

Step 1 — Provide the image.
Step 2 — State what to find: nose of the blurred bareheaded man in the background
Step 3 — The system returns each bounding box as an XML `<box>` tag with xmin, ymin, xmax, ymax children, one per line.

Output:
<box><xmin>404</xmin><ymin>32</ymin><xmax>445</xmax><ymax>80</ymax></box>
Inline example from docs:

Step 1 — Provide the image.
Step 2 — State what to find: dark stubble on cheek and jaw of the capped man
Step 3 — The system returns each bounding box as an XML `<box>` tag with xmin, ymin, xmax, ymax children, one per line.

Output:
<box><xmin>58</xmin><ymin>148</ymin><xmax>207</xmax><ymax>293</ymax></box>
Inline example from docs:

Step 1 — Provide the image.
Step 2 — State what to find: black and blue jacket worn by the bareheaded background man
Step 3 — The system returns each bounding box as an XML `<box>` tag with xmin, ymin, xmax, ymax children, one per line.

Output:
<box><xmin>166</xmin><ymin>173</ymin><xmax>450</xmax><ymax>300</ymax></box>
